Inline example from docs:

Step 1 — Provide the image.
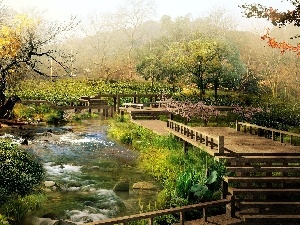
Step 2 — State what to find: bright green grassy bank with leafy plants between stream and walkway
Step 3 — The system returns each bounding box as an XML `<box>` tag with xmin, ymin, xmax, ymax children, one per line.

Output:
<box><xmin>108</xmin><ymin>117</ymin><xmax>225</xmax><ymax>222</ymax></box>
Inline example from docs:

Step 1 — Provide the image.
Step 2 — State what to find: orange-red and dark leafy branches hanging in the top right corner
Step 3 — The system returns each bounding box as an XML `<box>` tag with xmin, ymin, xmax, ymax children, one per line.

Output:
<box><xmin>241</xmin><ymin>0</ymin><xmax>300</xmax><ymax>56</ymax></box>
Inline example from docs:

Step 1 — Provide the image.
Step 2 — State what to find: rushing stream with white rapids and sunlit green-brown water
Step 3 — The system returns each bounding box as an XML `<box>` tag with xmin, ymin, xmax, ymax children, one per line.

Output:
<box><xmin>2</xmin><ymin>120</ymin><xmax>161</xmax><ymax>224</ymax></box>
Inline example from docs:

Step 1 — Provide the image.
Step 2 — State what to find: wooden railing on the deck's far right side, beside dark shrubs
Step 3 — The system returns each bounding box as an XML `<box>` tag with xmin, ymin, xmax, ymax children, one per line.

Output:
<box><xmin>236</xmin><ymin>121</ymin><xmax>300</xmax><ymax>145</ymax></box>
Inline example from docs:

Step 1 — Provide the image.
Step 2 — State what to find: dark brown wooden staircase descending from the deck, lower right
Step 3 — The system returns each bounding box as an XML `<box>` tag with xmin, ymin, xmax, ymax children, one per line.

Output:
<box><xmin>219</xmin><ymin>153</ymin><xmax>300</xmax><ymax>224</ymax></box>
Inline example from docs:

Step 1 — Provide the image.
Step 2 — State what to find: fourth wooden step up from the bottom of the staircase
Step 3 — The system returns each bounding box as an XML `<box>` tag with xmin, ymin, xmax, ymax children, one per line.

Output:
<box><xmin>224</xmin><ymin>177</ymin><xmax>300</xmax><ymax>183</ymax></box>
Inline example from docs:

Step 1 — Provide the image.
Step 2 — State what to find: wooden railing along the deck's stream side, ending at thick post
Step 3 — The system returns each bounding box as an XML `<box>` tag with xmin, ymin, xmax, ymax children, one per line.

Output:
<box><xmin>167</xmin><ymin>119</ymin><xmax>224</xmax><ymax>155</ymax></box>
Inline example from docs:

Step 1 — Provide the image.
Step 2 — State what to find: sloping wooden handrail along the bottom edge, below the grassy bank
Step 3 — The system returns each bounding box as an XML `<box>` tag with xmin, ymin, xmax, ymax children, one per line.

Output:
<box><xmin>85</xmin><ymin>199</ymin><xmax>232</xmax><ymax>225</ymax></box>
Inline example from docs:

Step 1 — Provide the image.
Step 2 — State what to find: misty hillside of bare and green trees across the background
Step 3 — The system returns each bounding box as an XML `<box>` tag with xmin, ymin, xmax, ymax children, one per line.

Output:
<box><xmin>0</xmin><ymin>0</ymin><xmax>300</xmax><ymax>100</ymax></box>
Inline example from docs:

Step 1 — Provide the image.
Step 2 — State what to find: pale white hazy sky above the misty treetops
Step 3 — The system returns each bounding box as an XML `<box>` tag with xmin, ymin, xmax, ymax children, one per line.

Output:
<box><xmin>4</xmin><ymin>0</ymin><xmax>292</xmax><ymax>30</ymax></box>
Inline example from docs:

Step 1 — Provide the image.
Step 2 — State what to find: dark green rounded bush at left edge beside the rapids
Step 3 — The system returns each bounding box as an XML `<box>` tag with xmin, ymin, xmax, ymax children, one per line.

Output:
<box><xmin>0</xmin><ymin>141</ymin><xmax>45</xmax><ymax>203</ymax></box>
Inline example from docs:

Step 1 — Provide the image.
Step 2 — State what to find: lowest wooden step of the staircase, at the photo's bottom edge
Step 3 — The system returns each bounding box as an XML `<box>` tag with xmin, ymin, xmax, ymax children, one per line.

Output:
<box><xmin>242</xmin><ymin>215</ymin><xmax>300</xmax><ymax>225</ymax></box>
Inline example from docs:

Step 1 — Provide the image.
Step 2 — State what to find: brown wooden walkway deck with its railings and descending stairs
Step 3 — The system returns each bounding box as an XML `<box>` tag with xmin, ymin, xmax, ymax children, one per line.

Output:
<box><xmin>84</xmin><ymin>120</ymin><xmax>300</xmax><ymax>225</ymax></box>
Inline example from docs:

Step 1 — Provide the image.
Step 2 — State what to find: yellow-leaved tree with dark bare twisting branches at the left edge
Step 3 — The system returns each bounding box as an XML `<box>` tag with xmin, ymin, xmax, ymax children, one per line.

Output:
<box><xmin>0</xmin><ymin>3</ymin><xmax>76</xmax><ymax>108</ymax></box>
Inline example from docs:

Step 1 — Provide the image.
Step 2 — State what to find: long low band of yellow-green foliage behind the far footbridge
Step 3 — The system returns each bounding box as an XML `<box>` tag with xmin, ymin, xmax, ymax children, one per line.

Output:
<box><xmin>7</xmin><ymin>79</ymin><xmax>176</xmax><ymax>104</ymax></box>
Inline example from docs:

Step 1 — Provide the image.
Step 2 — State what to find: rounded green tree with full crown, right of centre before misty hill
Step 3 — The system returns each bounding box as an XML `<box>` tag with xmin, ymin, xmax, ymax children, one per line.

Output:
<box><xmin>172</xmin><ymin>38</ymin><xmax>244</xmax><ymax>100</ymax></box>
